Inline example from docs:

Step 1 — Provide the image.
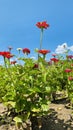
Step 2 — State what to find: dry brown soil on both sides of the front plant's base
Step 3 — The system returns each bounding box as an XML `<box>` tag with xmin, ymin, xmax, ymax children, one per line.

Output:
<box><xmin>0</xmin><ymin>99</ymin><xmax>73</xmax><ymax>130</ymax></box>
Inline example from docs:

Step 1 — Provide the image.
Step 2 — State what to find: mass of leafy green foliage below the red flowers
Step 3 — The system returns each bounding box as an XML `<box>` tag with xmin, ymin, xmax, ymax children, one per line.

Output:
<box><xmin>0</xmin><ymin>50</ymin><xmax>73</xmax><ymax>123</ymax></box>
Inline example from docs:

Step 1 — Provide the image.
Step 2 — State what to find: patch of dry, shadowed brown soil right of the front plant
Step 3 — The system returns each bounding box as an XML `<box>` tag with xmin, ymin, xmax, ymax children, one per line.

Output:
<box><xmin>42</xmin><ymin>99</ymin><xmax>73</xmax><ymax>130</ymax></box>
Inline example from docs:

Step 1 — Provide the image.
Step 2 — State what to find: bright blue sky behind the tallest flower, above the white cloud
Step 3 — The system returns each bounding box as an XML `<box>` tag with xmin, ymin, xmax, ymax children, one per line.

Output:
<box><xmin>0</xmin><ymin>0</ymin><xmax>73</xmax><ymax>61</ymax></box>
